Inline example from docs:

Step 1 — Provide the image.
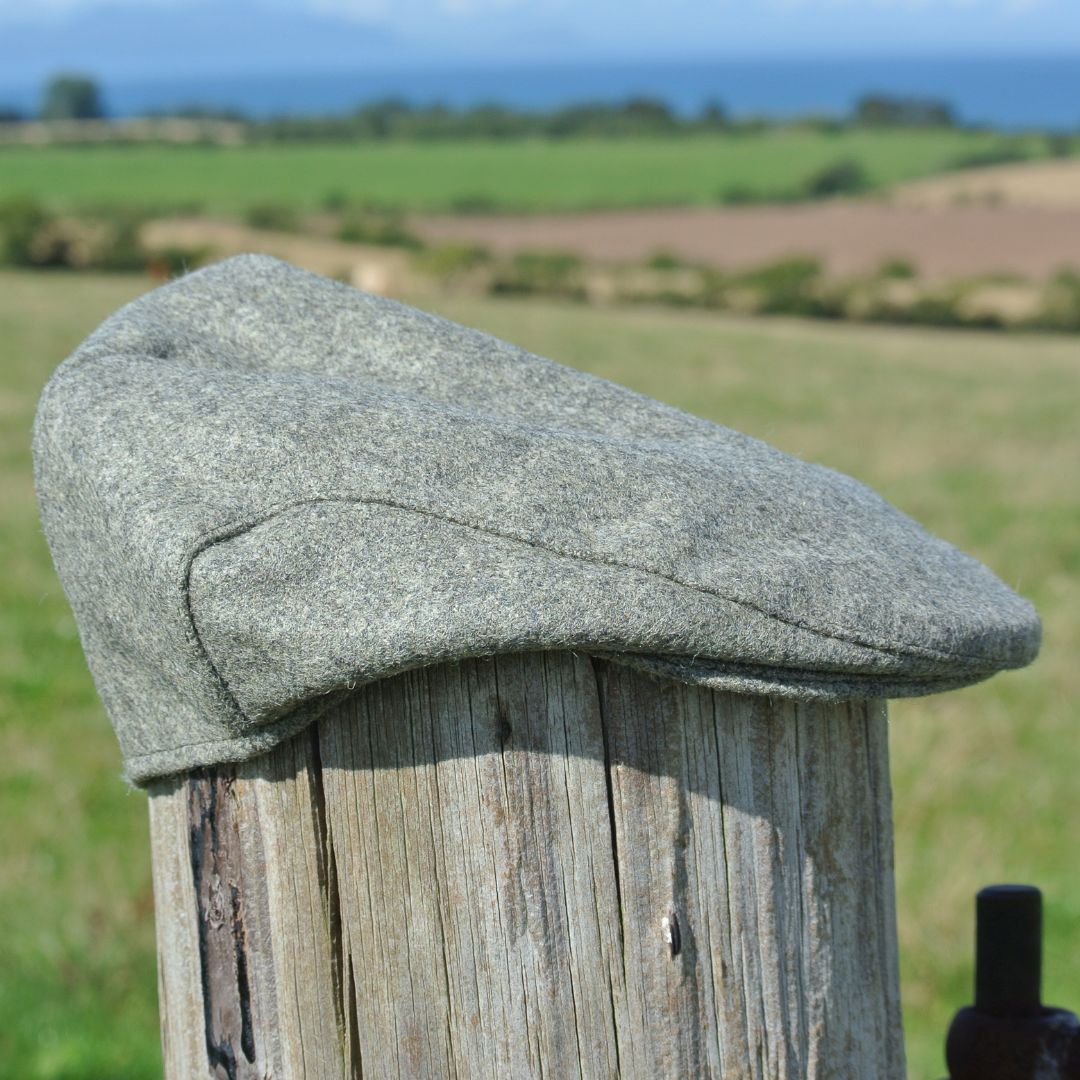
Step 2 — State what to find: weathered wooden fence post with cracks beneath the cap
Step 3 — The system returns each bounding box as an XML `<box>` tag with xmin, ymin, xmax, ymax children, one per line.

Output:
<box><xmin>143</xmin><ymin>652</ymin><xmax>904</xmax><ymax>1080</ymax></box>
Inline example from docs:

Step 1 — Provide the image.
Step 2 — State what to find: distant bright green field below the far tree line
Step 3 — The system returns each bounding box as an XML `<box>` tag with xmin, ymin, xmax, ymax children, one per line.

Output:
<box><xmin>0</xmin><ymin>130</ymin><xmax>1042</xmax><ymax>213</ymax></box>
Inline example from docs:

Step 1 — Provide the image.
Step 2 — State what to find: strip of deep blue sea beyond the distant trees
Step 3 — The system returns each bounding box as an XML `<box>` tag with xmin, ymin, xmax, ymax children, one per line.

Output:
<box><xmin>6</xmin><ymin>53</ymin><xmax>1080</xmax><ymax>131</ymax></box>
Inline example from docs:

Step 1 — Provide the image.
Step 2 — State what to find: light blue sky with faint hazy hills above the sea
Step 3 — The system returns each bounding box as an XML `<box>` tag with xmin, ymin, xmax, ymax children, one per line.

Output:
<box><xmin>0</xmin><ymin>0</ymin><xmax>1080</xmax><ymax>85</ymax></box>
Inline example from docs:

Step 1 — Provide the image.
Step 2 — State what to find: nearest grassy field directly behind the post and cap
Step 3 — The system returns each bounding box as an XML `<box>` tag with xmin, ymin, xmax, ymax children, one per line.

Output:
<box><xmin>0</xmin><ymin>265</ymin><xmax>1080</xmax><ymax>1080</ymax></box>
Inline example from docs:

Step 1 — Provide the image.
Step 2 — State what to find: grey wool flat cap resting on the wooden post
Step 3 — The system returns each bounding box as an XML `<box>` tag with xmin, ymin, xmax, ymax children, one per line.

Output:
<box><xmin>35</xmin><ymin>256</ymin><xmax>1039</xmax><ymax>783</ymax></box>
